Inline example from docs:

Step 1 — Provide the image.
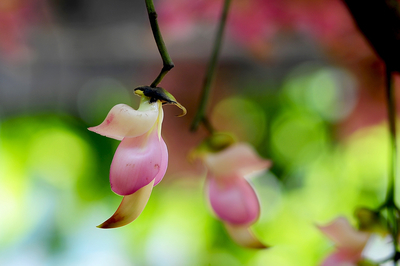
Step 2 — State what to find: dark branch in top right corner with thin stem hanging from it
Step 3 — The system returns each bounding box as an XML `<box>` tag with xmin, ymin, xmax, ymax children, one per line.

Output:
<box><xmin>343</xmin><ymin>0</ymin><xmax>400</xmax><ymax>258</ymax></box>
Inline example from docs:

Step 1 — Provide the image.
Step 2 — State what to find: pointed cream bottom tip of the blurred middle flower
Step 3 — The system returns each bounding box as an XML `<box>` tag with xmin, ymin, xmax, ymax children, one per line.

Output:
<box><xmin>225</xmin><ymin>223</ymin><xmax>269</xmax><ymax>249</ymax></box>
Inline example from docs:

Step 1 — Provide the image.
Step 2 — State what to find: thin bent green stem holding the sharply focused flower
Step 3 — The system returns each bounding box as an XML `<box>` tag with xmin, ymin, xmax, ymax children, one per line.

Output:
<box><xmin>145</xmin><ymin>0</ymin><xmax>174</xmax><ymax>88</ymax></box>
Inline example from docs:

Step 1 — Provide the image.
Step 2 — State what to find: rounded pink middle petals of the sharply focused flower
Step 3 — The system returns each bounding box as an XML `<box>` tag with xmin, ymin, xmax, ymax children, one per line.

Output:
<box><xmin>110</xmin><ymin>127</ymin><xmax>167</xmax><ymax>195</ymax></box>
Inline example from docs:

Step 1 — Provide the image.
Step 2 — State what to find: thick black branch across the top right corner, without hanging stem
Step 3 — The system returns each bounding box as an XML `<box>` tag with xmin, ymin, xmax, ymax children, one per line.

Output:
<box><xmin>343</xmin><ymin>0</ymin><xmax>400</xmax><ymax>72</ymax></box>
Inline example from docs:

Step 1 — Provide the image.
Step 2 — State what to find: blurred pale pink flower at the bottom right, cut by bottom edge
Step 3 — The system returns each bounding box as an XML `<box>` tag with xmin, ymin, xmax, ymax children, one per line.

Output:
<box><xmin>318</xmin><ymin>217</ymin><xmax>370</xmax><ymax>266</ymax></box>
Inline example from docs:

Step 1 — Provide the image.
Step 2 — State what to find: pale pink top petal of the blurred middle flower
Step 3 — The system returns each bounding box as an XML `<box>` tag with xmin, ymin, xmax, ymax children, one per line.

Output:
<box><xmin>204</xmin><ymin>143</ymin><xmax>271</xmax><ymax>177</ymax></box>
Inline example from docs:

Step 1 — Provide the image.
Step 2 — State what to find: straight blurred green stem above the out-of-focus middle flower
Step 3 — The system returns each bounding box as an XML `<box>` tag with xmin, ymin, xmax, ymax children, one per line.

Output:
<box><xmin>190</xmin><ymin>0</ymin><xmax>231</xmax><ymax>131</ymax></box>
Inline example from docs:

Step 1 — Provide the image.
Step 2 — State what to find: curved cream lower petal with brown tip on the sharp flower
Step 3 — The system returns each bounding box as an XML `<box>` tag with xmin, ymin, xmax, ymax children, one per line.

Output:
<box><xmin>97</xmin><ymin>180</ymin><xmax>154</xmax><ymax>228</ymax></box>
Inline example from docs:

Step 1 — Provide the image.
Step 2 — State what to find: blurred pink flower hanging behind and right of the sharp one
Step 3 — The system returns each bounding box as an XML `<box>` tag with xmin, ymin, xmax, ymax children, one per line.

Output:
<box><xmin>203</xmin><ymin>143</ymin><xmax>271</xmax><ymax>248</ymax></box>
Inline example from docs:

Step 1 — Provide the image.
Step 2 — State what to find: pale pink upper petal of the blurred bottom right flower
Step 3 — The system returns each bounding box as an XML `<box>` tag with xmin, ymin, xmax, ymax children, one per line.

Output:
<box><xmin>318</xmin><ymin>217</ymin><xmax>370</xmax><ymax>252</ymax></box>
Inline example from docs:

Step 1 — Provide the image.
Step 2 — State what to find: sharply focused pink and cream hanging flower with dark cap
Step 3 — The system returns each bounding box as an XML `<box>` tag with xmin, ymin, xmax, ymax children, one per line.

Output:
<box><xmin>89</xmin><ymin>86</ymin><xmax>186</xmax><ymax>228</ymax></box>
